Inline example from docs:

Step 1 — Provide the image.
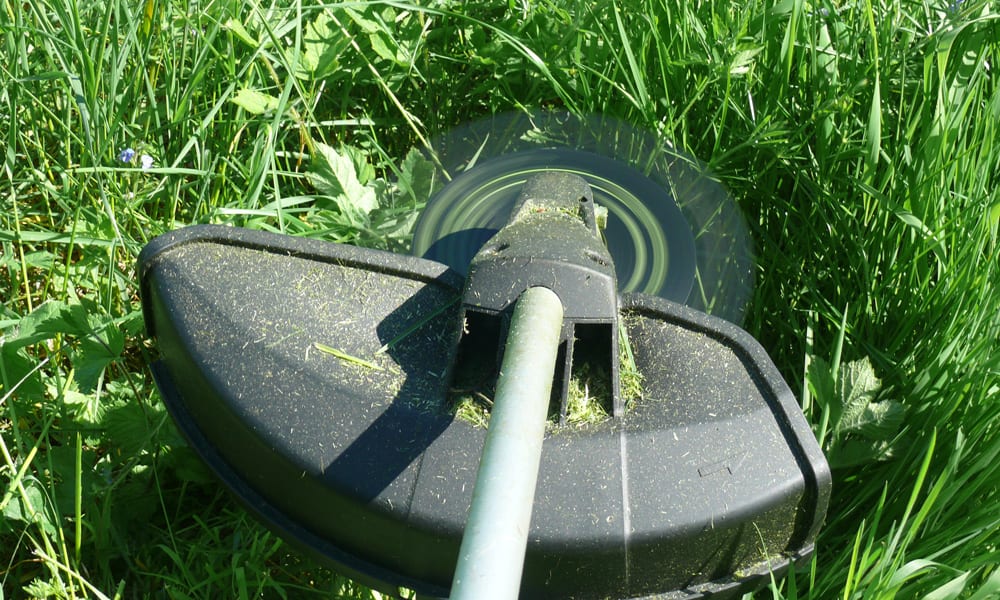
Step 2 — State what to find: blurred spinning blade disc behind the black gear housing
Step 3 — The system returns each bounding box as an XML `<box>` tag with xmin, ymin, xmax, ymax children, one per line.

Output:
<box><xmin>413</xmin><ymin>112</ymin><xmax>753</xmax><ymax>323</ymax></box>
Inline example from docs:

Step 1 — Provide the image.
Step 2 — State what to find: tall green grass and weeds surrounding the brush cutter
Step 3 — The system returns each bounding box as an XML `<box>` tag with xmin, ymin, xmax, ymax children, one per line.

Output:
<box><xmin>0</xmin><ymin>0</ymin><xmax>1000</xmax><ymax>600</ymax></box>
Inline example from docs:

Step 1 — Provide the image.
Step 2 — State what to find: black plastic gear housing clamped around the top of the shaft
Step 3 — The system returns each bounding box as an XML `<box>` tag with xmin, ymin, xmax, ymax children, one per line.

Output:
<box><xmin>459</xmin><ymin>172</ymin><xmax>627</xmax><ymax>422</ymax></box>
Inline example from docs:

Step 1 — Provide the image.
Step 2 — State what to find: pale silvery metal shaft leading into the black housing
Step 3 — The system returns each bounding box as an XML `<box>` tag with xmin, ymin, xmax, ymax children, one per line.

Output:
<box><xmin>451</xmin><ymin>287</ymin><xmax>563</xmax><ymax>600</ymax></box>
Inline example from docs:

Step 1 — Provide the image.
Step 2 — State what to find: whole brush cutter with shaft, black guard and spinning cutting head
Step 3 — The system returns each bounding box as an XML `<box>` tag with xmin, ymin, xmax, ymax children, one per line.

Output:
<box><xmin>139</xmin><ymin>115</ymin><xmax>830</xmax><ymax>598</ymax></box>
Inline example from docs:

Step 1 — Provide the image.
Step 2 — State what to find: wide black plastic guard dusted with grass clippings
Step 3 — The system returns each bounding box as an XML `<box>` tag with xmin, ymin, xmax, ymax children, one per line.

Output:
<box><xmin>139</xmin><ymin>226</ymin><xmax>830</xmax><ymax>598</ymax></box>
